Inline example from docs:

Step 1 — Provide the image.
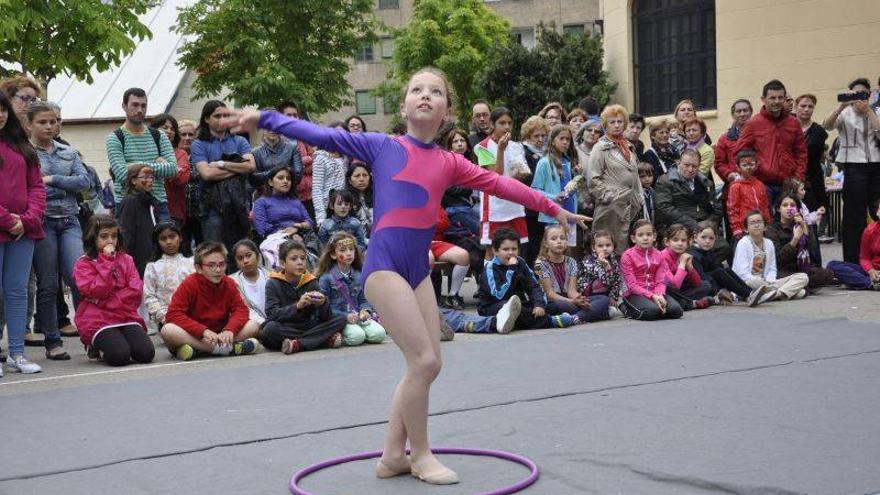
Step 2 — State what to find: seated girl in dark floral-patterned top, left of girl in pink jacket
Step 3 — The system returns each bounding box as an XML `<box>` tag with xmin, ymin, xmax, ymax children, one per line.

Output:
<box><xmin>577</xmin><ymin>230</ymin><xmax>623</xmax><ymax>318</ymax></box>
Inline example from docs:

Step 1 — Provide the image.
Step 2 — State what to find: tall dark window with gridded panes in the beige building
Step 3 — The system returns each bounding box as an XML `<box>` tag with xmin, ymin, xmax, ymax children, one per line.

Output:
<box><xmin>632</xmin><ymin>0</ymin><xmax>718</xmax><ymax>115</ymax></box>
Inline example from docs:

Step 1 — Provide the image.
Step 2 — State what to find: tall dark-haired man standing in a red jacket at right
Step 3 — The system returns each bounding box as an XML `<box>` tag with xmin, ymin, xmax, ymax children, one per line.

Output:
<box><xmin>736</xmin><ymin>79</ymin><xmax>807</xmax><ymax>204</ymax></box>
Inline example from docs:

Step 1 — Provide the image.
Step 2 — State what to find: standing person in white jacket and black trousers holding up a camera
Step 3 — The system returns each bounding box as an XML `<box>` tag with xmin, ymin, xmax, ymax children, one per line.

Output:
<box><xmin>822</xmin><ymin>78</ymin><xmax>880</xmax><ymax>263</ymax></box>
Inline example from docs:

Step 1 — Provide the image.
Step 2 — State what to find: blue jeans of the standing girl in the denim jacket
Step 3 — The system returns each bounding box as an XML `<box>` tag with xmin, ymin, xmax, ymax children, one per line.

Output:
<box><xmin>34</xmin><ymin>216</ymin><xmax>83</xmax><ymax>349</ymax></box>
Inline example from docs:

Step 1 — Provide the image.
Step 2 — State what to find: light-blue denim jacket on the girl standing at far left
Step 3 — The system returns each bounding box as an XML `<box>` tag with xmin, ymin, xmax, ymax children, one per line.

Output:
<box><xmin>35</xmin><ymin>141</ymin><xmax>90</xmax><ymax>217</ymax></box>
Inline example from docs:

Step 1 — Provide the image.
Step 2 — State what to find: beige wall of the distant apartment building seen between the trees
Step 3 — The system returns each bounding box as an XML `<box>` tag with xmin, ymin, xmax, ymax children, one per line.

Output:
<box><xmin>318</xmin><ymin>0</ymin><xmax>601</xmax><ymax>131</ymax></box>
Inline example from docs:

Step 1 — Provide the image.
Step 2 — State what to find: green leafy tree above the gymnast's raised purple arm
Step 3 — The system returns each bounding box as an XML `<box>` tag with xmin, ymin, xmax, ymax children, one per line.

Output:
<box><xmin>177</xmin><ymin>0</ymin><xmax>377</xmax><ymax>113</ymax></box>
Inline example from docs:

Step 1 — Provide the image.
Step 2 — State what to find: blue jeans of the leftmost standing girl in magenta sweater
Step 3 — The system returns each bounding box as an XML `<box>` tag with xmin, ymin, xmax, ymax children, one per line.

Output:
<box><xmin>0</xmin><ymin>238</ymin><xmax>34</xmax><ymax>355</ymax></box>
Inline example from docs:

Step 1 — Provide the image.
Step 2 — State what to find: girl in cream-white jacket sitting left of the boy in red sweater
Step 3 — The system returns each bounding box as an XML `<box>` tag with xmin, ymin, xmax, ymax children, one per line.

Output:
<box><xmin>144</xmin><ymin>222</ymin><xmax>195</xmax><ymax>335</ymax></box>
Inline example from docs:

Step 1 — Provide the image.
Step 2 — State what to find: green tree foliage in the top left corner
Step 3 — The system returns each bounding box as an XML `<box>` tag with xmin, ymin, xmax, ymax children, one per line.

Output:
<box><xmin>0</xmin><ymin>0</ymin><xmax>152</xmax><ymax>87</ymax></box>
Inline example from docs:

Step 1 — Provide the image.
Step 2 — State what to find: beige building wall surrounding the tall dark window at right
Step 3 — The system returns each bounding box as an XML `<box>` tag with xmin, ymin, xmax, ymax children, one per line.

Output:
<box><xmin>603</xmin><ymin>0</ymin><xmax>880</xmax><ymax>145</ymax></box>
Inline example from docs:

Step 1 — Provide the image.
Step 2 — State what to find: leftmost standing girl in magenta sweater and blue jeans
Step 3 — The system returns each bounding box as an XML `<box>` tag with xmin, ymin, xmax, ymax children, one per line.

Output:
<box><xmin>0</xmin><ymin>91</ymin><xmax>46</xmax><ymax>376</ymax></box>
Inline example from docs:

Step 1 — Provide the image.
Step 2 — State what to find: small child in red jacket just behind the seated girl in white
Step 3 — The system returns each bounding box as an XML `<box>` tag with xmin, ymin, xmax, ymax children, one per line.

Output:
<box><xmin>727</xmin><ymin>150</ymin><xmax>772</xmax><ymax>244</ymax></box>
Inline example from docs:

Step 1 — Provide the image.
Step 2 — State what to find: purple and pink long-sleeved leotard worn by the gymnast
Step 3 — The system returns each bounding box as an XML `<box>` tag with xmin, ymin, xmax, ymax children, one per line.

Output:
<box><xmin>259</xmin><ymin>111</ymin><xmax>559</xmax><ymax>289</ymax></box>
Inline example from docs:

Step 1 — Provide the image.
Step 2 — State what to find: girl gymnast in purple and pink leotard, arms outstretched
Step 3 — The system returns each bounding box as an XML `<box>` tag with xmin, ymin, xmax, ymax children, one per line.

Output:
<box><xmin>224</xmin><ymin>68</ymin><xmax>590</xmax><ymax>484</ymax></box>
